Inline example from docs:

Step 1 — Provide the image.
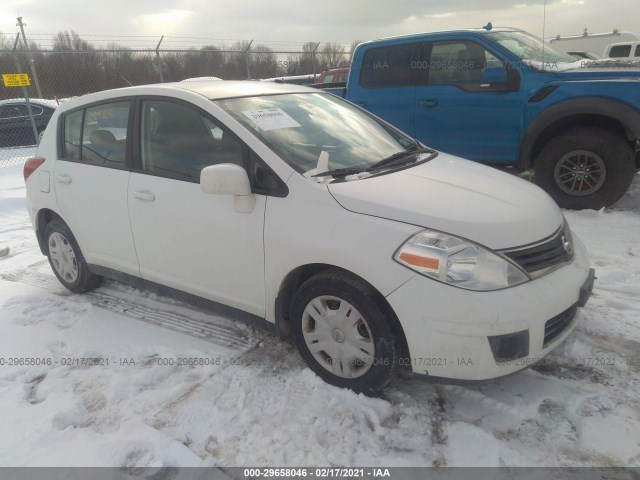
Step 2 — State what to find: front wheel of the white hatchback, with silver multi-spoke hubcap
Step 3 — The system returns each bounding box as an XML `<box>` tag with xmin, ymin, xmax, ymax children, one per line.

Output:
<box><xmin>290</xmin><ymin>271</ymin><xmax>401</xmax><ymax>395</ymax></box>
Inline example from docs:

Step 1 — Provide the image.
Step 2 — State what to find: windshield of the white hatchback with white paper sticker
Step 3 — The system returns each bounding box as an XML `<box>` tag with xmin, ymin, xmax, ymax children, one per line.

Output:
<box><xmin>216</xmin><ymin>93</ymin><xmax>417</xmax><ymax>173</ymax></box>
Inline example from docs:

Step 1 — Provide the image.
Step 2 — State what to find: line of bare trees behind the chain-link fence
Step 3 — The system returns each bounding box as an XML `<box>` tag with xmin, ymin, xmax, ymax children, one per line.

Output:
<box><xmin>0</xmin><ymin>30</ymin><xmax>359</xmax><ymax>98</ymax></box>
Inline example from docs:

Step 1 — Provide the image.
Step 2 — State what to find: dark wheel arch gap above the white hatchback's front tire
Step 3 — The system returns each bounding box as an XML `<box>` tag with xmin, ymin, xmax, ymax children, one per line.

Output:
<box><xmin>275</xmin><ymin>263</ymin><xmax>409</xmax><ymax>363</ymax></box>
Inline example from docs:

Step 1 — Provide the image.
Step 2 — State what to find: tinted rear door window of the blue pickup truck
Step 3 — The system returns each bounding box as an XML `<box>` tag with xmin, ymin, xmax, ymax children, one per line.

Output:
<box><xmin>360</xmin><ymin>43</ymin><xmax>421</xmax><ymax>88</ymax></box>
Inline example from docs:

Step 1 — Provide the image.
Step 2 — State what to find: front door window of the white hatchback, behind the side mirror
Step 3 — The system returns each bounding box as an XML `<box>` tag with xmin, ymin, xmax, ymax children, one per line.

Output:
<box><xmin>140</xmin><ymin>100</ymin><xmax>244</xmax><ymax>182</ymax></box>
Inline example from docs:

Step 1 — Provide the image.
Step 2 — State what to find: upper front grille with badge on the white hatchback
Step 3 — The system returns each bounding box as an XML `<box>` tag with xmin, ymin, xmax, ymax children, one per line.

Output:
<box><xmin>500</xmin><ymin>227</ymin><xmax>573</xmax><ymax>273</ymax></box>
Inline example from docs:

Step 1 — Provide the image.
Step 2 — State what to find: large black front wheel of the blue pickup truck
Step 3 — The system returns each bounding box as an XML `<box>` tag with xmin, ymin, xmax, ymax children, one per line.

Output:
<box><xmin>534</xmin><ymin>127</ymin><xmax>635</xmax><ymax>210</ymax></box>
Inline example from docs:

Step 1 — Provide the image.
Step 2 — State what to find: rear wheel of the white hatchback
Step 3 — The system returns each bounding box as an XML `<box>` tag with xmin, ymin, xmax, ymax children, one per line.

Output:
<box><xmin>44</xmin><ymin>219</ymin><xmax>102</xmax><ymax>293</ymax></box>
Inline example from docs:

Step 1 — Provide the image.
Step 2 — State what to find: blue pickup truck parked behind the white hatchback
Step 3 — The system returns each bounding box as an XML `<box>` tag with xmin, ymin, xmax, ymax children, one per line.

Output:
<box><xmin>334</xmin><ymin>26</ymin><xmax>640</xmax><ymax>209</ymax></box>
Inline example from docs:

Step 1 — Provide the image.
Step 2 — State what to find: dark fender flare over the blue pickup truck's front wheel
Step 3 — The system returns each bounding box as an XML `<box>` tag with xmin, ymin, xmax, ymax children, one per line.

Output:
<box><xmin>518</xmin><ymin>97</ymin><xmax>640</xmax><ymax>170</ymax></box>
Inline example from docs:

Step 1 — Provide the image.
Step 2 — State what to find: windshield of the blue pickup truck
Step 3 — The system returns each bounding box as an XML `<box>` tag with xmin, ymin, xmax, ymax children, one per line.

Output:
<box><xmin>488</xmin><ymin>31</ymin><xmax>576</xmax><ymax>69</ymax></box>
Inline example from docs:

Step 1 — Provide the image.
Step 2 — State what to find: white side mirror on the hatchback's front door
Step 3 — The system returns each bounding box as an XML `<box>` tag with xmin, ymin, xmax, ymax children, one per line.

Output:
<box><xmin>200</xmin><ymin>163</ymin><xmax>255</xmax><ymax>213</ymax></box>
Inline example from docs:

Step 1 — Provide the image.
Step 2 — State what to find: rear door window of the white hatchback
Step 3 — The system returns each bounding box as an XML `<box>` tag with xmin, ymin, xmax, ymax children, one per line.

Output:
<box><xmin>62</xmin><ymin>101</ymin><xmax>131</xmax><ymax>168</ymax></box>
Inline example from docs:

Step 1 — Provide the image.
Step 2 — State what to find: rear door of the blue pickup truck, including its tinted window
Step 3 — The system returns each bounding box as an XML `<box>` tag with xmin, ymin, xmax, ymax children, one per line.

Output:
<box><xmin>347</xmin><ymin>42</ymin><xmax>421</xmax><ymax>137</ymax></box>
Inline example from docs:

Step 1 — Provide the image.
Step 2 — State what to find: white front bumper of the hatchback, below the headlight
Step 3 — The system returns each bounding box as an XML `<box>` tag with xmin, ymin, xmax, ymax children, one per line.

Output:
<box><xmin>387</xmin><ymin>236</ymin><xmax>594</xmax><ymax>380</ymax></box>
